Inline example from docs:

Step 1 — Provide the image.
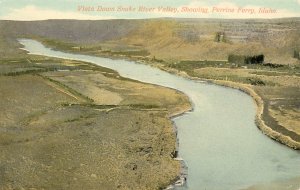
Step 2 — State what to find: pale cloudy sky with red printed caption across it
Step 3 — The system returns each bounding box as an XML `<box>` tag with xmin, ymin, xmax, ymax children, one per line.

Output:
<box><xmin>0</xmin><ymin>0</ymin><xmax>300</xmax><ymax>20</ymax></box>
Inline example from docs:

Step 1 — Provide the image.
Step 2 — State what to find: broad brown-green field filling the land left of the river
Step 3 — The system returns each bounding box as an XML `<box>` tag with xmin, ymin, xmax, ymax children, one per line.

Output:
<box><xmin>0</xmin><ymin>49</ymin><xmax>190</xmax><ymax>189</ymax></box>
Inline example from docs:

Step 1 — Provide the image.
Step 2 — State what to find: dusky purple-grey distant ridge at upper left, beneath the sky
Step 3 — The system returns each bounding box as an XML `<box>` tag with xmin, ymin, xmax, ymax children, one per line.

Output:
<box><xmin>0</xmin><ymin>20</ymin><xmax>139</xmax><ymax>43</ymax></box>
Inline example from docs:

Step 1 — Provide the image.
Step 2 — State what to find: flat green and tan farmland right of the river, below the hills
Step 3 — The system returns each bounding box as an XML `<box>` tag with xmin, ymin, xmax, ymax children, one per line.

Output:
<box><xmin>38</xmin><ymin>39</ymin><xmax>300</xmax><ymax>149</ymax></box>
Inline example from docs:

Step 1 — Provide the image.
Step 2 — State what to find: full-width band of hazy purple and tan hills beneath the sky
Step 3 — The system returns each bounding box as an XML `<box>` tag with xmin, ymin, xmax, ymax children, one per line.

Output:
<box><xmin>0</xmin><ymin>18</ymin><xmax>300</xmax><ymax>64</ymax></box>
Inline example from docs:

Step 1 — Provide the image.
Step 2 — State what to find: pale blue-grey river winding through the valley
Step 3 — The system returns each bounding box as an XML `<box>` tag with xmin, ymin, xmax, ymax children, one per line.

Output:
<box><xmin>19</xmin><ymin>39</ymin><xmax>300</xmax><ymax>190</ymax></box>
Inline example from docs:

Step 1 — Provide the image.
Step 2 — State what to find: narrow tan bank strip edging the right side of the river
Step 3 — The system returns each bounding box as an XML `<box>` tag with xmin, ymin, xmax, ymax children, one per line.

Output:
<box><xmin>38</xmin><ymin>39</ymin><xmax>300</xmax><ymax>149</ymax></box>
